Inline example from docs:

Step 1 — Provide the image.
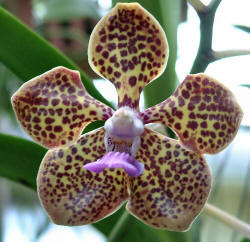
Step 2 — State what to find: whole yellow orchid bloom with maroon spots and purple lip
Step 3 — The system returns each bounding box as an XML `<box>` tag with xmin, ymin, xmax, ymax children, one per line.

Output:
<box><xmin>12</xmin><ymin>3</ymin><xmax>242</xmax><ymax>231</ymax></box>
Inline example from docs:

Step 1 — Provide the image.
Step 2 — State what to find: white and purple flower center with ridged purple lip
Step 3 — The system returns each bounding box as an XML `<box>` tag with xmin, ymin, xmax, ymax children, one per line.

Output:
<box><xmin>84</xmin><ymin>107</ymin><xmax>144</xmax><ymax>177</ymax></box>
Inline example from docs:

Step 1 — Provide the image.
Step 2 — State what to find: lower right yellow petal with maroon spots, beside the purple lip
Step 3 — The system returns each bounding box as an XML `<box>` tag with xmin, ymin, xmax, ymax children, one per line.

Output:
<box><xmin>127</xmin><ymin>128</ymin><xmax>211</xmax><ymax>231</ymax></box>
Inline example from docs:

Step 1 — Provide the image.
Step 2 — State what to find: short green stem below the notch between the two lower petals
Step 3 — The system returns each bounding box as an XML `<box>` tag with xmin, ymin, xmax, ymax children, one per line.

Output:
<box><xmin>107</xmin><ymin>210</ymin><xmax>132</xmax><ymax>242</ymax></box>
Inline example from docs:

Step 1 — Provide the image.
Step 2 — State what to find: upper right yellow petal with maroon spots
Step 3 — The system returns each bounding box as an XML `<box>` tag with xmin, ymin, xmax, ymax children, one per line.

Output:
<box><xmin>142</xmin><ymin>73</ymin><xmax>243</xmax><ymax>154</ymax></box>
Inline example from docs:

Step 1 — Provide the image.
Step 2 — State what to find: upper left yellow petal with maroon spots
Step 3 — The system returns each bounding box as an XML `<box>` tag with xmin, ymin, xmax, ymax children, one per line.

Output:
<box><xmin>11</xmin><ymin>67</ymin><xmax>113</xmax><ymax>148</ymax></box>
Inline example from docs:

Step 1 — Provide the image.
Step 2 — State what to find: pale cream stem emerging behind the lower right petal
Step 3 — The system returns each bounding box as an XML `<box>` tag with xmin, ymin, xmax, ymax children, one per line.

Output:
<box><xmin>203</xmin><ymin>203</ymin><xmax>250</xmax><ymax>238</ymax></box>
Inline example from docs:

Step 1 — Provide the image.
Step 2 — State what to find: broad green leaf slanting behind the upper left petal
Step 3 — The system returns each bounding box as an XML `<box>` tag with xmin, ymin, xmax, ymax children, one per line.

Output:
<box><xmin>0</xmin><ymin>7</ymin><xmax>111</xmax><ymax>106</ymax></box>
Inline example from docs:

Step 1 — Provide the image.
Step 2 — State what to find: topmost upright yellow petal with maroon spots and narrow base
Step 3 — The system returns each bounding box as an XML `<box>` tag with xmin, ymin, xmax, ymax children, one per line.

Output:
<box><xmin>88</xmin><ymin>3</ymin><xmax>168</xmax><ymax>109</ymax></box>
